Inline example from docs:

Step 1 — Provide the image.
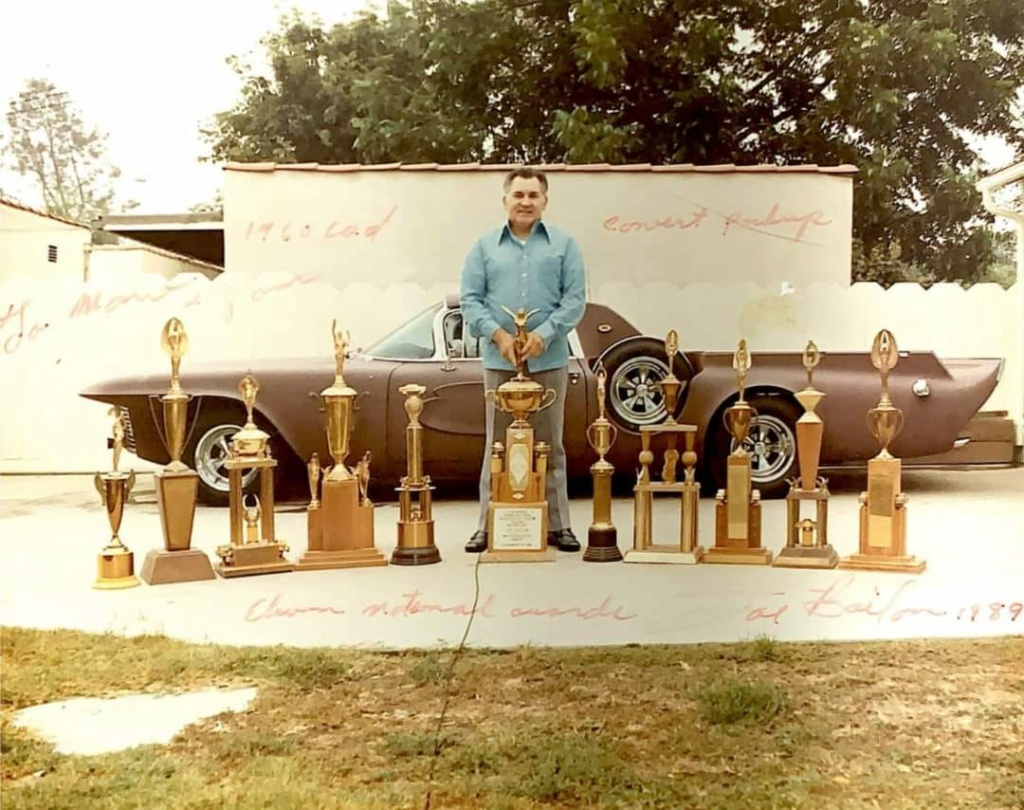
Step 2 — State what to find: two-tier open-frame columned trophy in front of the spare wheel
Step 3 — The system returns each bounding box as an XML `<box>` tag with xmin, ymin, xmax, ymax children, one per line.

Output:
<box><xmin>625</xmin><ymin>330</ymin><xmax>705</xmax><ymax>565</ymax></box>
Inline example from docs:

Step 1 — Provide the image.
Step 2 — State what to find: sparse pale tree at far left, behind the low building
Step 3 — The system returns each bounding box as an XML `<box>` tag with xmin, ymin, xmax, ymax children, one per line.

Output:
<box><xmin>0</xmin><ymin>79</ymin><xmax>134</xmax><ymax>222</ymax></box>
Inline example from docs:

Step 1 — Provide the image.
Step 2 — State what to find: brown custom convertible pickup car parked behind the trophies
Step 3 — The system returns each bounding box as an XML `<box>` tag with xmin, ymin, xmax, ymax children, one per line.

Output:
<box><xmin>81</xmin><ymin>296</ymin><xmax>1002</xmax><ymax>504</ymax></box>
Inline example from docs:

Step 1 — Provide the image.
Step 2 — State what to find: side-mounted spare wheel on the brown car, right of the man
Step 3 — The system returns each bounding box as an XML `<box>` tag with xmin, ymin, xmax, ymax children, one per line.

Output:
<box><xmin>600</xmin><ymin>338</ymin><xmax>693</xmax><ymax>431</ymax></box>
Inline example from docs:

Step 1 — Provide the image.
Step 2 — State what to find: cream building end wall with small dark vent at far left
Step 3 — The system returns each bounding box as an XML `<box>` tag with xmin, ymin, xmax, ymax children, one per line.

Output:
<box><xmin>0</xmin><ymin>202</ymin><xmax>91</xmax><ymax>285</ymax></box>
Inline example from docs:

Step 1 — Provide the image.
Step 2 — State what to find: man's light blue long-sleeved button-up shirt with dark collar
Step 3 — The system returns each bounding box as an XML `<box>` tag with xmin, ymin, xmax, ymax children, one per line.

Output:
<box><xmin>461</xmin><ymin>220</ymin><xmax>587</xmax><ymax>372</ymax></box>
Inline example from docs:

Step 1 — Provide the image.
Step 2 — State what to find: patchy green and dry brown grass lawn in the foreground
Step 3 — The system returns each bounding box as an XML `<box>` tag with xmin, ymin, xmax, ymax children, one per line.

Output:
<box><xmin>2</xmin><ymin>628</ymin><xmax>1024</xmax><ymax>810</ymax></box>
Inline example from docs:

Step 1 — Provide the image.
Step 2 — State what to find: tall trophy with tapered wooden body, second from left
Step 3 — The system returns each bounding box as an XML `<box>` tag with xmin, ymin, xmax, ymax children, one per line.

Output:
<box><xmin>139</xmin><ymin>317</ymin><xmax>215</xmax><ymax>585</ymax></box>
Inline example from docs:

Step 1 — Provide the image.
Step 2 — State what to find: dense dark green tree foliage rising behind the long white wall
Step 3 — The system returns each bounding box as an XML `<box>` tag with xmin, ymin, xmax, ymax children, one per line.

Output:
<box><xmin>207</xmin><ymin>0</ymin><xmax>1024</xmax><ymax>282</ymax></box>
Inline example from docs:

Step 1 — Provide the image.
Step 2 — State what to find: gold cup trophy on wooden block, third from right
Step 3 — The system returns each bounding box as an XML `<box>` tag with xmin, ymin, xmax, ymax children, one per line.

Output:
<box><xmin>706</xmin><ymin>340</ymin><xmax>772</xmax><ymax>565</ymax></box>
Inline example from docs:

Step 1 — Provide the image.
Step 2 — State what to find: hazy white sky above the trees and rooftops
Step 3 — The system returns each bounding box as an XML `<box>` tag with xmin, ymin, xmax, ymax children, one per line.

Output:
<box><xmin>0</xmin><ymin>0</ymin><xmax>1013</xmax><ymax>214</ymax></box>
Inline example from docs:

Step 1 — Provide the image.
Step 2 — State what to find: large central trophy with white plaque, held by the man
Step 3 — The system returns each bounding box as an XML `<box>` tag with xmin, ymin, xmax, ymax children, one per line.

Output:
<box><xmin>480</xmin><ymin>307</ymin><xmax>556</xmax><ymax>562</ymax></box>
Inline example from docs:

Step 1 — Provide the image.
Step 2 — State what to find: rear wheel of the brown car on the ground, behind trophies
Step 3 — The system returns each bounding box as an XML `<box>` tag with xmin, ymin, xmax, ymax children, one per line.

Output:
<box><xmin>706</xmin><ymin>394</ymin><xmax>801</xmax><ymax>500</ymax></box>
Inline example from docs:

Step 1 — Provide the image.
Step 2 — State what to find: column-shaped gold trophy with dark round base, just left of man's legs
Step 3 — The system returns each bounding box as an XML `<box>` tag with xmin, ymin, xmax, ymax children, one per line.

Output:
<box><xmin>391</xmin><ymin>383</ymin><xmax>441</xmax><ymax>565</ymax></box>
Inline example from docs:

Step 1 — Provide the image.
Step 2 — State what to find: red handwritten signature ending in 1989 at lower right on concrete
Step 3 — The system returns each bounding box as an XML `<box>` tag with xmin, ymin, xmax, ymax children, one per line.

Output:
<box><xmin>746</xmin><ymin>578</ymin><xmax>1024</xmax><ymax>625</ymax></box>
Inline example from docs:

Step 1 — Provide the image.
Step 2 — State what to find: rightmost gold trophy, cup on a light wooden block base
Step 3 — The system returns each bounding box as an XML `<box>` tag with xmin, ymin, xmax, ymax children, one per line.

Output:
<box><xmin>839</xmin><ymin>329</ymin><xmax>926</xmax><ymax>573</ymax></box>
